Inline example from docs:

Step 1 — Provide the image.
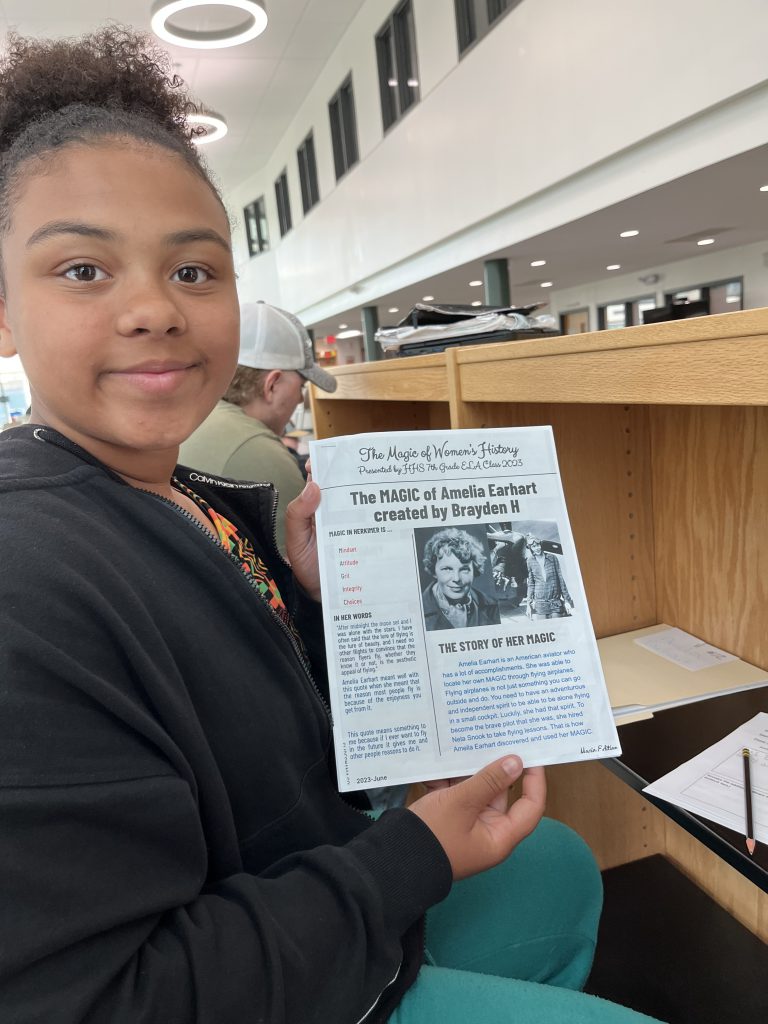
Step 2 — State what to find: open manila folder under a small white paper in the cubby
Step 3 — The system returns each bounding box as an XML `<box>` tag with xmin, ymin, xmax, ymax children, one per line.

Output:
<box><xmin>597</xmin><ymin>624</ymin><xmax>768</xmax><ymax>724</ymax></box>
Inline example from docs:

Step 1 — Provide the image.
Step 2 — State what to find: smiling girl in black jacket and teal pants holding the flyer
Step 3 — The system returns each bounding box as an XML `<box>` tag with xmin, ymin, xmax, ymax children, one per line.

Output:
<box><xmin>0</xmin><ymin>29</ymin><xmax>663</xmax><ymax>1024</ymax></box>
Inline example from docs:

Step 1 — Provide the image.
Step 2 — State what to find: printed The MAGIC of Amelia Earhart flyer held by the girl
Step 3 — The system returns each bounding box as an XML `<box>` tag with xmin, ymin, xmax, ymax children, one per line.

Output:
<box><xmin>310</xmin><ymin>427</ymin><xmax>621</xmax><ymax>792</ymax></box>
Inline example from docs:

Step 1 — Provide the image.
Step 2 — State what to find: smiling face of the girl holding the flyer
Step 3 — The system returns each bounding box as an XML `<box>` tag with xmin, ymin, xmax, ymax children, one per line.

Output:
<box><xmin>0</xmin><ymin>140</ymin><xmax>239</xmax><ymax>464</ymax></box>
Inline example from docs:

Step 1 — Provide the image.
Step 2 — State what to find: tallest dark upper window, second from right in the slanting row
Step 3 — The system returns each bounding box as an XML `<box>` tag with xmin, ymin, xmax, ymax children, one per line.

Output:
<box><xmin>376</xmin><ymin>0</ymin><xmax>419</xmax><ymax>131</ymax></box>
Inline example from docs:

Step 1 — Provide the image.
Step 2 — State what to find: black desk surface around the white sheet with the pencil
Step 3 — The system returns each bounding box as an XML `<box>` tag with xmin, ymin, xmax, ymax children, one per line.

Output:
<box><xmin>605</xmin><ymin>685</ymin><xmax>768</xmax><ymax>892</ymax></box>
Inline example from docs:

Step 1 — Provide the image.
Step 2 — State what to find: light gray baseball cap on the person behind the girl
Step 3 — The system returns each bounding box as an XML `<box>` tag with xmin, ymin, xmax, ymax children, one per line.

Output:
<box><xmin>238</xmin><ymin>302</ymin><xmax>338</xmax><ymax>391</ymax></box>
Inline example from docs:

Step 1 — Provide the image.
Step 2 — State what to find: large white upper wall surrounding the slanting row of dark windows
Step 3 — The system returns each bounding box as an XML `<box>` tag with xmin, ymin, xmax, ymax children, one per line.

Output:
<box><xmin>227</xmin><ymin>0</ymin><xmax>768</xmax><ymax>323</ymax></box>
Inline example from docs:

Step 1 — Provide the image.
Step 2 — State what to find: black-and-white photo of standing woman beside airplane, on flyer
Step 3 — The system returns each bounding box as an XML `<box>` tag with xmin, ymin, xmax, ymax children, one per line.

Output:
<box><xmin>486</xmin><ymin>520</ymin><xmax>573</xmax><ymax>622</ymax></box>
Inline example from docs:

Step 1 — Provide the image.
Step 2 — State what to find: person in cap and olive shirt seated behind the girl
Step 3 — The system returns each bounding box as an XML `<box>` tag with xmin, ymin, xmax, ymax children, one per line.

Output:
<box><xmin>179</xmin><ymin>302</ymin><xmax>336</xmax><ymax>554</ymax></box>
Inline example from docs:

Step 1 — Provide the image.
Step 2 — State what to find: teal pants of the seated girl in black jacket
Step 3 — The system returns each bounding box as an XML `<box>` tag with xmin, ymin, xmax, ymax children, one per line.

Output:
<box><xmin>389</xmin><ymin>818</ymin><xmax>663</xmax><ymax>1024</ymax></box>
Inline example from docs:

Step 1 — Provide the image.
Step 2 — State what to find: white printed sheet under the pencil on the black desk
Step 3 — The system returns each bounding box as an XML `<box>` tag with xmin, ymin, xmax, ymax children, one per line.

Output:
<box><xmin>643</xmin><ymin>712</ymin><xmax>768</xmax><ymax>843</ymax></box>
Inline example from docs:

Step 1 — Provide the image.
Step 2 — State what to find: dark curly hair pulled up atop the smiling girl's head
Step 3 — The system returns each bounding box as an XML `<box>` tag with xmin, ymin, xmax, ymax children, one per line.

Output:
<box><xmin>0</xmin><ymin>25</ymin><xmax>220</xmax><ymax>232</ymax></box>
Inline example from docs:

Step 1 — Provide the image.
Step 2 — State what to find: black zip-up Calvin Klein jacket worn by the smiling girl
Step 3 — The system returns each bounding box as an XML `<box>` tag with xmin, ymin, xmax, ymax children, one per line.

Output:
<box><xmin>0</xmin><ymin>425</ymin><xmax>451</xmax><ymax>1024</ymax></box>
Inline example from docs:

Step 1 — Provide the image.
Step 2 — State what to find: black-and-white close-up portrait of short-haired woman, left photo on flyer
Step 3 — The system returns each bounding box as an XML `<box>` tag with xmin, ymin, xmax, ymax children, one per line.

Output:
<box><xmin>414</xmin><ymin>525</ymin><xmax>501</xmax><ymax>631</ymax></box>
